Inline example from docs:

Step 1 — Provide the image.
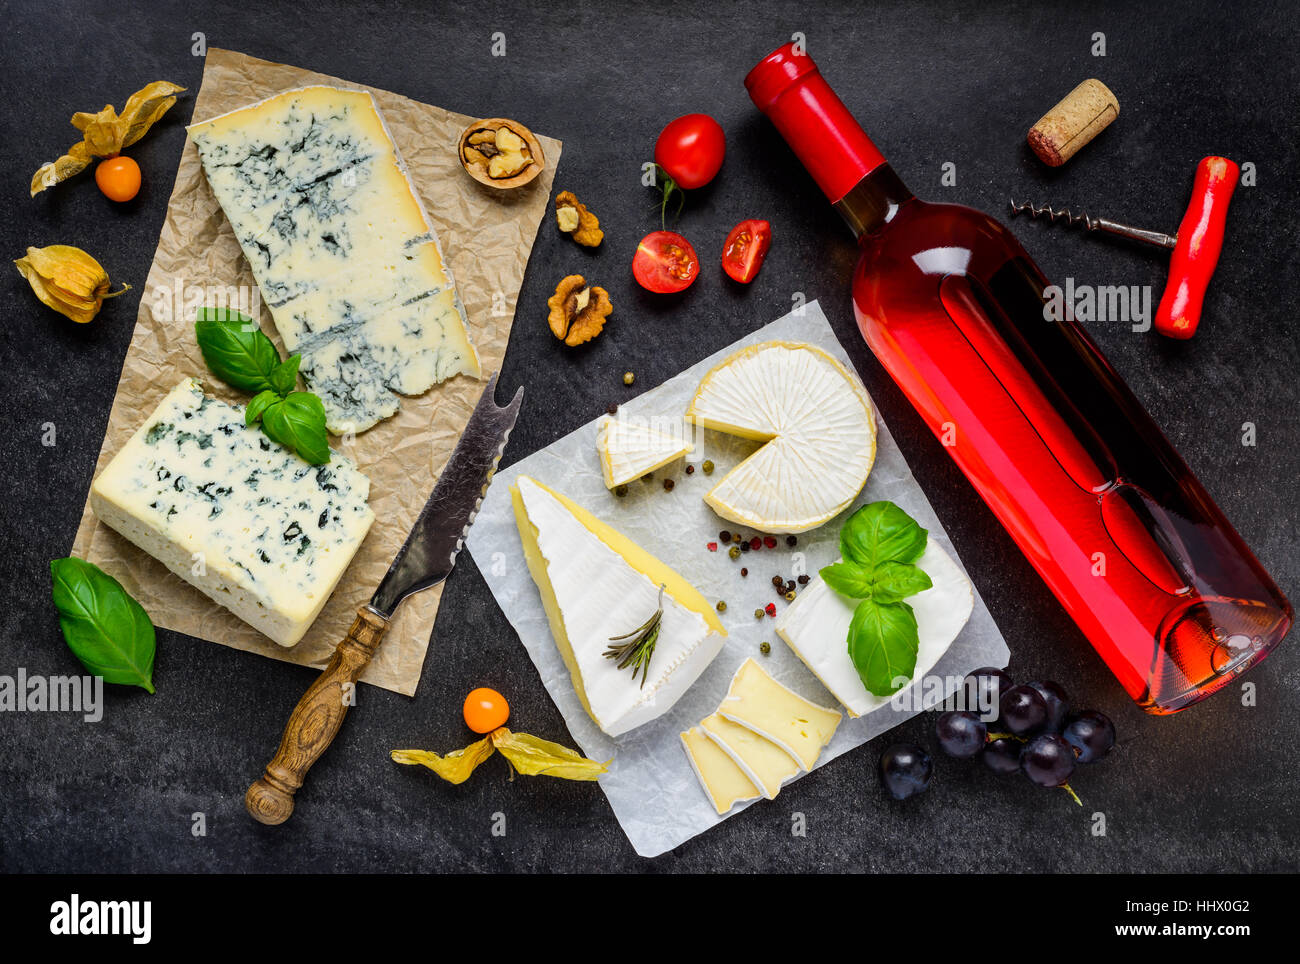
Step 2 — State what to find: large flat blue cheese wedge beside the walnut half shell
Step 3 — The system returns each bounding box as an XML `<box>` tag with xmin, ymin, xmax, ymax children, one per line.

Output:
<box><xmin>189</xmin><ymin>87</ymin><xmax>480</xmax><ymax>434</ymax></box>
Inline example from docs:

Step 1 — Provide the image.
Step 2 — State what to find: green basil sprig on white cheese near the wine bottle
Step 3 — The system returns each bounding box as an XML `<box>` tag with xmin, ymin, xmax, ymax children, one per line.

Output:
<box><xmin>822</xmin><ymin>501</ymin><xmax>933</xmax><ymax>696</ymax></box>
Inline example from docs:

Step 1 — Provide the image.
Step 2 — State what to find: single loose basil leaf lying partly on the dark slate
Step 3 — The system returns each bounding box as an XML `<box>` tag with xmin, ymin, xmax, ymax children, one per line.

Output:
<box><xmin>49</xmin><ymin>556</ymin><xmax>156</xmax><ymax>692</ymax></box>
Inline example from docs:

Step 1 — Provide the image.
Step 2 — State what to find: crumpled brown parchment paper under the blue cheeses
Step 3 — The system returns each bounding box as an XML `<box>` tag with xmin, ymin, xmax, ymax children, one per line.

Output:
<box><xmin>73</xmin><ymin>48</ymin><xmax>562</xmax><ymax>696</ymax></box>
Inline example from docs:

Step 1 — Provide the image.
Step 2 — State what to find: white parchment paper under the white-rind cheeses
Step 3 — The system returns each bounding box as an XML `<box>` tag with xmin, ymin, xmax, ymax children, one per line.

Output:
<box><xmin>468</xmin><ymin>301</ymin><xmax>1010</xmax><ymax>856</ymax></box>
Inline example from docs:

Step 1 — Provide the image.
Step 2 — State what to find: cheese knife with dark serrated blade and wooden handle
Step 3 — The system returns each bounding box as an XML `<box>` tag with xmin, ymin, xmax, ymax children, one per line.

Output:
<box><xmin>244</xmin><ymin>374</ymin><xmax>524</xmax><ymax>825</ymax></box>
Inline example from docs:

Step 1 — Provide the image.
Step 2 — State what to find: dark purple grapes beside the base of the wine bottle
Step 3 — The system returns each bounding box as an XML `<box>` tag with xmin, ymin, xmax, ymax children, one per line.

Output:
<box><xmin>880</xmin><ymin>666</ymin><xmax>1115</xmax><ymax>803</ymax></box>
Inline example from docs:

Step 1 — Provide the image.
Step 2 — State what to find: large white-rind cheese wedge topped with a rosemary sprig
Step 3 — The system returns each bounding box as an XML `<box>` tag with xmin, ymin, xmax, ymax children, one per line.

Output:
<box><xmin>511</xmin><ymin>476</ymin><xmax>727</xmax><ymax>737</ymax></box>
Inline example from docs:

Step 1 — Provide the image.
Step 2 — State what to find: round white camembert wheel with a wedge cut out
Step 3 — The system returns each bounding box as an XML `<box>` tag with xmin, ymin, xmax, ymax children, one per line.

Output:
<box><xmin>686</xmin><ymin>342</ymin><xmax>876</xmax><ymax>533</ymax></box>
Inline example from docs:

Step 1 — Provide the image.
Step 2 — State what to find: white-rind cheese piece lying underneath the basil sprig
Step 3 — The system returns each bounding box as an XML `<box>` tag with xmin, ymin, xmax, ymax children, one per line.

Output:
<box><xmin>776</xmin><ymin>539</ymin><xmax>975</xmax><ymax>717</ymax></box>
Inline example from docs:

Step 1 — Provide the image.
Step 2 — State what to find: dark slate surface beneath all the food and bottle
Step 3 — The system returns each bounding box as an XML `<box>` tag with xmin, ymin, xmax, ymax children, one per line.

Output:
<box><xmin>0</xmin><ymin>0</ymin><xmax>1300</xmax><ymax>873</ymax></box>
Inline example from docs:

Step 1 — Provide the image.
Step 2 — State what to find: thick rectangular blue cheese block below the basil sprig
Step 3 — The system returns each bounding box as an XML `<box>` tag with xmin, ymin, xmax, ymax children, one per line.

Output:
<box><xmin>90</xmin><ymin>378</ymin><xmax>374</xmax><ymax>646</ymax></box>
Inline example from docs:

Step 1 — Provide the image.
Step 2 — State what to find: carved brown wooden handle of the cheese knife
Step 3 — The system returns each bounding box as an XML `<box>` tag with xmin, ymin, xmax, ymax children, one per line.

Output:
<box><xmin>244</xmin><ymin>605</ymin><xmax>389</xmax><ymax>825</ymax></box>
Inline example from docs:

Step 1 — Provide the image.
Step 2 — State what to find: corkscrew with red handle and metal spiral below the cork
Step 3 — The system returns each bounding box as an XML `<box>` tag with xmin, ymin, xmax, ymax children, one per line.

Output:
<box><xmin>1011</xmin><ymin>157</ymin><xmax>1240</xmax><ymax>338</ymax></box>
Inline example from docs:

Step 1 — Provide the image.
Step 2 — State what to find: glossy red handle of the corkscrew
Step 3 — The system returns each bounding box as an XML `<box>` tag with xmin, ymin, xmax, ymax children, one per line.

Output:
<box><xmin>1156</xmin><ymin>157</ymin><xmax>1242</xmax><ymax>339</ymax></box>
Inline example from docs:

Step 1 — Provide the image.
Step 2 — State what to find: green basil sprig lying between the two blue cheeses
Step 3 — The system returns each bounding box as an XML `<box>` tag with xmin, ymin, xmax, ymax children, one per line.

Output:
<box><xmin>194</xmin><ymin>308</ymin><xmax>330</xmax><ymax>465</ymax></box>
